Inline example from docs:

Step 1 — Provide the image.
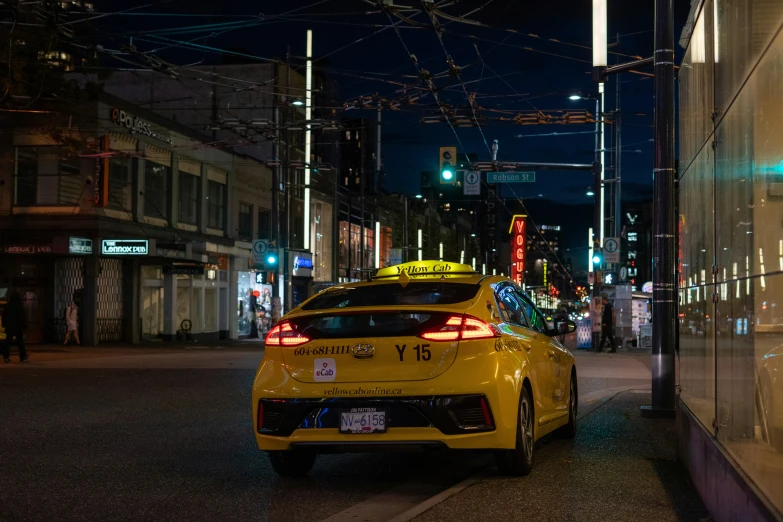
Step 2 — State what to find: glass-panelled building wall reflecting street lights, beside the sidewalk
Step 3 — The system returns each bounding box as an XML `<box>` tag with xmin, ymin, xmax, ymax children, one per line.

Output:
<box><xmin>680</xmin><ymin>0</ymin><xmax>783</xmax><ymax>520</ymax></box>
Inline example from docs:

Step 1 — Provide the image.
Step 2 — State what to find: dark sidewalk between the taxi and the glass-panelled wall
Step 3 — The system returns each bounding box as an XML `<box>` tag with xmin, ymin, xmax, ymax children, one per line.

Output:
<box><xmin>415</xmin><ymin>391</ymin><xmax>709</xmax><ymax>522</ymax></box>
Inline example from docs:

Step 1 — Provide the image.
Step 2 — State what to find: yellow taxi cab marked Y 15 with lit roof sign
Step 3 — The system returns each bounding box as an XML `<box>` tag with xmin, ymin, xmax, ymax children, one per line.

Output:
<box><xmin>252</xmin><ymin>261</ymin><xmax>578</xmax><ymax>476</ymax></box>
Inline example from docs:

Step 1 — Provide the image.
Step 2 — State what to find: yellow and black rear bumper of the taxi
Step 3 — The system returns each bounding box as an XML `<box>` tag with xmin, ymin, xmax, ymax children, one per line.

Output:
<box><xmin>252</xmin><ymin>341</ymin><xmax>528</xmax><ymax>452</ymax></box>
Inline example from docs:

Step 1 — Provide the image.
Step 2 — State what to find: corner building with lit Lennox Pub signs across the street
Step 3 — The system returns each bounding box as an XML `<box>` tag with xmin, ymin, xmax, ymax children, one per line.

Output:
<box><xmin>0</xmin><ymin>95</ymin><xmax>270</xmax><ymax>345</ymax></box>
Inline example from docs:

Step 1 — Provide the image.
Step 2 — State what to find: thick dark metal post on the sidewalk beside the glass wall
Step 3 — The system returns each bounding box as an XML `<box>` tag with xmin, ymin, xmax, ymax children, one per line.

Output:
<box><xmin>642</xmin><ymin>0</ymin><xmax>677</xmax><ymax>417</ymax></box>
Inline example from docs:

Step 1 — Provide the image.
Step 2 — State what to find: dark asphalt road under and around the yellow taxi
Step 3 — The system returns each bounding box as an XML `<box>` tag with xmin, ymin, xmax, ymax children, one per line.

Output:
<box><xmin>0</xmin><ymin>346</ymin><xmax>660</xmax><ymax>521</ymax></box>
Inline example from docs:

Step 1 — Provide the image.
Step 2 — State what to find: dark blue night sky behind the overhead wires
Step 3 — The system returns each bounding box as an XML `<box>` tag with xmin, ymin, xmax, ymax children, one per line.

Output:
<box><xmin>96</xmin><ymin>0</ymin><xmax>689</xmax><ymax>240</ymax></box>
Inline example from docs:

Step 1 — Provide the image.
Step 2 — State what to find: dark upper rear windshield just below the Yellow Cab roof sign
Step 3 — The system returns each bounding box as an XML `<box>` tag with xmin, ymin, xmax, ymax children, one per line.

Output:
<box><xmin>302</xmin><ymin>282</ymin><xmax>480</xmax><ymax>310</ymax></box>
